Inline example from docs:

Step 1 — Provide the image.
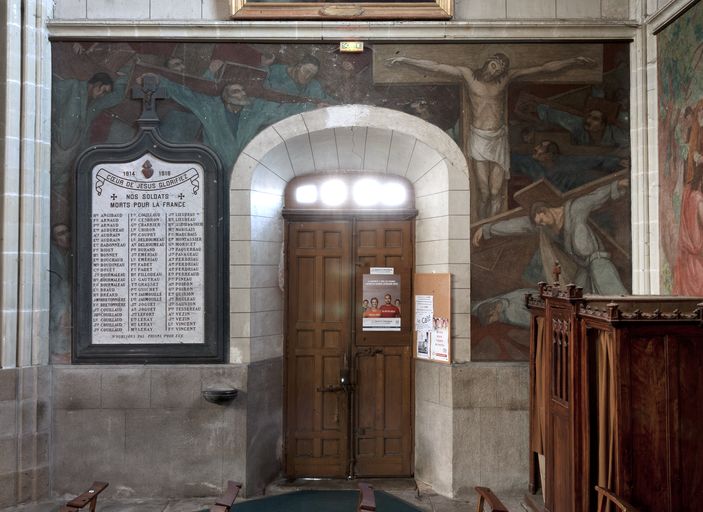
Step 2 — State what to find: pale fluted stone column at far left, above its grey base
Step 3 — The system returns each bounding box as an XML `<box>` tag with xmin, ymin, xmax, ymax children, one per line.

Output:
<box><xmin>0</xmin><ymin>0</ymin><xmax>52</xmax><ymax>368</ymax></box>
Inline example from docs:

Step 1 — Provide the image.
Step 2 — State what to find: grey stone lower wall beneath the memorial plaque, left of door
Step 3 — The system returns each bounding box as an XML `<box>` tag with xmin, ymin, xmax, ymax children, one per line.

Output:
<box><xmin>52</xmin><ymin>365</ymin><xmax>250</xmax><ymax>497</ymax></box>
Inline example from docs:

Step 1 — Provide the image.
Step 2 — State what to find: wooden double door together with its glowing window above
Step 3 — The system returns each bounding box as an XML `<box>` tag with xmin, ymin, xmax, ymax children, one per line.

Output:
<box><xmin>283</xmin><ymin>172</ymin><xmax>417</xmax><ymax>477</ymax></box>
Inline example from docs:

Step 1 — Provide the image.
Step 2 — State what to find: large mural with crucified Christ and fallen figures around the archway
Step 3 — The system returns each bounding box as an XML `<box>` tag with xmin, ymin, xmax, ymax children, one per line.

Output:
<box><xmin>51</xmin><ymin>42</ymin><xmax>630</xmax><ymax>362</ymax></box>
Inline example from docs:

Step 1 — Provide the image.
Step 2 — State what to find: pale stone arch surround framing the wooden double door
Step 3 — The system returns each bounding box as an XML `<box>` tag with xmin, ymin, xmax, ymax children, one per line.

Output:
<box><xmin>230</xmin><ymin>105</ymin><xmax>470</xmax><ymax>484</ymax></box>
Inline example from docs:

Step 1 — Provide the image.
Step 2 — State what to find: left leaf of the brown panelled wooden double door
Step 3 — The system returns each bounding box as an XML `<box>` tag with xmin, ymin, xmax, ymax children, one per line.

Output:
<box><xmin>286</xmin><ymin>222</ymin><xmax>351</xmax><ymax>477</ymax></box>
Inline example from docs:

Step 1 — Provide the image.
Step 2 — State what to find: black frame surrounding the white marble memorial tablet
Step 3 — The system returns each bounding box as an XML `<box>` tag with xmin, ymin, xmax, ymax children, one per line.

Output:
<box><xmin>71</xmin><ymin>120</ymin><xmax>229</xmax><ymax>364</ymax></box>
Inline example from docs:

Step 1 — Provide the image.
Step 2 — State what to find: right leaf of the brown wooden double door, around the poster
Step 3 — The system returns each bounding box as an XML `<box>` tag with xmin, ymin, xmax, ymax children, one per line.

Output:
<box><xmin>353</xmin><ymin>221</ymin><xmax>413</xmax><ymax>477</ymax></box>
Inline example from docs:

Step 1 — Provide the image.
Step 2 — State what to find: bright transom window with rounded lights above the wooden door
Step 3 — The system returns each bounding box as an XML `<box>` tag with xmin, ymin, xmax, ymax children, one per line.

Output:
<box><xmin>285</xmin><ymin>172</ymin><xmax>415</xmax><ymax>212</ymax></box>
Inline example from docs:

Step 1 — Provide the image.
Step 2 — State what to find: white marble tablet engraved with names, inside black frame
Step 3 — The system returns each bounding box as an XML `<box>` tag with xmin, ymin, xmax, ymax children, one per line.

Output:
<box><xmin>91</xmin><ymin>155</ymin><xmax>205</xmax><ymax>344</ymax></box>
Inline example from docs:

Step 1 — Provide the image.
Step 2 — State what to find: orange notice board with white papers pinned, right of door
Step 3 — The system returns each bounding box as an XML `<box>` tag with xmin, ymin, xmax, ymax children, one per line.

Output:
<box><xmin>413</xmin><ymin>274</ymin><xmax>452</xmax><ymax>363</ymax></box>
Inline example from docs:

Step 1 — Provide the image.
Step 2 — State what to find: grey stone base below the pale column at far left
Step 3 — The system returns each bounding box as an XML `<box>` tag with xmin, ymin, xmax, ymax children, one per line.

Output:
<box><xmin>0</xmin><ymin>366</ymin><xmax>51</xmax><ymax>508</ymax></box>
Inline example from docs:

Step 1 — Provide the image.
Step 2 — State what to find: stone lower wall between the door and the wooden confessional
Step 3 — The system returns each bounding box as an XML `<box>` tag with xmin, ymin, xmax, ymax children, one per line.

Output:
<box><xmin>415</xmin><ymin>361</ymin><xmax>529</xmax><ymax>498</ymax></box>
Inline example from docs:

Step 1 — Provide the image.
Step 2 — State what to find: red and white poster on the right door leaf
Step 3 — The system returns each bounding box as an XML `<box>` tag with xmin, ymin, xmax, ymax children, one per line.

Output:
<box><xmin>362</xmin><ymin>267</ymin><xmax>400</xmax><ymax>331</ymax></box>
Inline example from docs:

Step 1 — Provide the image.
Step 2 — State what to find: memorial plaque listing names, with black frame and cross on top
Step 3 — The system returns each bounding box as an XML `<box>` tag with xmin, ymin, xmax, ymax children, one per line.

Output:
<box><xmin>72</xmin><ymin>75</ymin><xmax>229</xmax><ymax>363</ymax></box>
